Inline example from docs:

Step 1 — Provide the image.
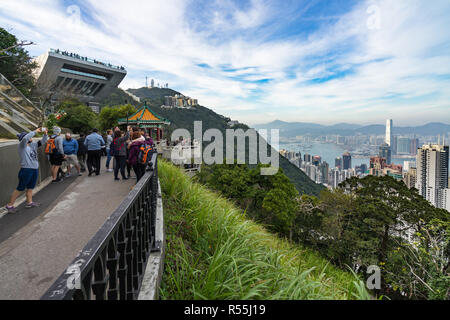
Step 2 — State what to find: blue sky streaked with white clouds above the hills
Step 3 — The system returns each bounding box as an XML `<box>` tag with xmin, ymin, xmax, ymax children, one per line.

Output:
<box><xmin>0</xmin><ymin>0</ymin><xmax>450</xmax><ymax>126</ymax></box>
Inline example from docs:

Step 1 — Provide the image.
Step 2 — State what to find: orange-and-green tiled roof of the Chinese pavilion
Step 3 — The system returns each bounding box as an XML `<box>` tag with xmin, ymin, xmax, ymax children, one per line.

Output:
<box><xmin>118</xmin><ymin>105</ymin><xmax>170</xmax><ymax>141</ymax></box>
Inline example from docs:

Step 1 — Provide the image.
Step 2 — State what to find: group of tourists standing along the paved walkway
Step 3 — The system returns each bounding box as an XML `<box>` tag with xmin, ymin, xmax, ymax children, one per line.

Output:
<box><xmin>6</xmin><ymin>126</ymin><xmax>154</xmax><ymax>213</ymax></box>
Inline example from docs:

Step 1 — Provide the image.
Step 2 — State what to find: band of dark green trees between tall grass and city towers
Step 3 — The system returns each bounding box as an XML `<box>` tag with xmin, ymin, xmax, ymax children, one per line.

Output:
<box><xmin>200</xmin><ymin>165</ymin><xmax>450</xmax><ymax>299</ymax></box>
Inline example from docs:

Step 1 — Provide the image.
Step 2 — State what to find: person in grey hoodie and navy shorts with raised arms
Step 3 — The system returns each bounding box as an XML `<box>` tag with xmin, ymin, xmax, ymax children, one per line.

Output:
<box><xmin>6</xmin><ymin>128</ymin><xmax>48</xmax><ymax>213</ymax></box>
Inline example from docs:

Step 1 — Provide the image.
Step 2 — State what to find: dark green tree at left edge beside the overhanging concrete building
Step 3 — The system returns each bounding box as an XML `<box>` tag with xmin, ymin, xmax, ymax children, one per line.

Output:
<box><xmin>0</xmin><ymin>28</ymin><xmax>37</xmax><ymax>97</ymax></box>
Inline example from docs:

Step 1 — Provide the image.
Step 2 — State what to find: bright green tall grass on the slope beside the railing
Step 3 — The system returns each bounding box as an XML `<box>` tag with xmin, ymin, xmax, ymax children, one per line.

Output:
<box><xmin>159</xmin><ymin>161</ymin><xmax>370</xmax><ymax>300</ymax></box>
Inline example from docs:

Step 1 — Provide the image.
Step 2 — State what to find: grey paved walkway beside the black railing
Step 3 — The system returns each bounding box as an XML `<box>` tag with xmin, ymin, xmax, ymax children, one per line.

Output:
<box><xmin>0</xmin><ymin>159</ymin><xmax>136</xmax><ymax>300</ymax></box>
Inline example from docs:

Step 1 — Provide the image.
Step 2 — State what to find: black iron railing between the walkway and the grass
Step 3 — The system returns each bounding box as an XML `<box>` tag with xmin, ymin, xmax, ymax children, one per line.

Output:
<box><xmin>41</xmin><ymin>153</ymin><xmax>160</xmax><ymax>300</ymax></box>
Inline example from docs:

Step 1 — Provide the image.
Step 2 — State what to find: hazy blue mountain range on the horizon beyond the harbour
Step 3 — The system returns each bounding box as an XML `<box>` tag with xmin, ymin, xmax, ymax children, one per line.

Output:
<box><xmin>254</xmin><ymin>120</ymin><xmax>450</xmax><ymax>138</ymax></box>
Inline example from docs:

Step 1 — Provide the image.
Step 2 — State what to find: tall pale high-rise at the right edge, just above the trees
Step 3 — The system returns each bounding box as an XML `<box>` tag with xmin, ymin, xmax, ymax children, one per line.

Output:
<box><xmin>416</xmin><ymin>144</ymin><xmax>450</xmax><ymax>210</ymax></box>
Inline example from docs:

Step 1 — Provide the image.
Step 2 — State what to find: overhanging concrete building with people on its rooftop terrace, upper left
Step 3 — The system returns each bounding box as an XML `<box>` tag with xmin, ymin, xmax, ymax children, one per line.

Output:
<box><xmin>35</xmin><ymin>49</ymin><xmax>127</xmax><ymax>104</ymax></box>
